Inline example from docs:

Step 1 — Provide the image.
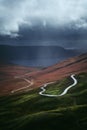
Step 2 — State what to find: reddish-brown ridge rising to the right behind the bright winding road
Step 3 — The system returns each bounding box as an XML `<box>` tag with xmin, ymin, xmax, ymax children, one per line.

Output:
<box><xmin>27</xmin><ymin>53</ymin><xmax>87</xmax><ymax>88</ymax></box>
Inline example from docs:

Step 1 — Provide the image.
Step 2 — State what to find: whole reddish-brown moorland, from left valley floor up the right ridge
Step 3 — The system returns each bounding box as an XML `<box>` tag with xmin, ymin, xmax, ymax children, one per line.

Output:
<box><xmin>0</xmin><ymin>53</ymin><xmax>87</xmax><ymax>94</ymax></box>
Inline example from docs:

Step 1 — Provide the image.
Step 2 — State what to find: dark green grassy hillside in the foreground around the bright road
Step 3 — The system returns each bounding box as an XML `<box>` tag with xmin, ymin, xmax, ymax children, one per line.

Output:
<box><xmin>0</xmin><ymin>74</ymin><xmax>87</xmax><ymax>130</ymax></box>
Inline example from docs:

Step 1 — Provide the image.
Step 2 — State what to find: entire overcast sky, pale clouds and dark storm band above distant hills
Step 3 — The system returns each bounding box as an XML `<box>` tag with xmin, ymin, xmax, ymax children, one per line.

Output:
<box><xmin>0</xmin><ymin>0</ymin><xmax>87</xmax><ymax>46</ymax></box>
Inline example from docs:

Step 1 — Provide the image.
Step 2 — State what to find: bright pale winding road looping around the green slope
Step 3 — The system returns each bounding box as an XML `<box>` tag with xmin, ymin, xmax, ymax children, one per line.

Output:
<box><xmin>39</xmin><ymin>74</ymin><xmax>77</xmax><ymax>97</ymax></box>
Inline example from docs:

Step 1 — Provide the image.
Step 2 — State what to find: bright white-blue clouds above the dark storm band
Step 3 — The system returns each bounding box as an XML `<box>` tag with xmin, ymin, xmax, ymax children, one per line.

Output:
<box><xmin>0</xmin><ymin>0</ymin><xmax>87</xmax><ymax>36</ymax></box>
